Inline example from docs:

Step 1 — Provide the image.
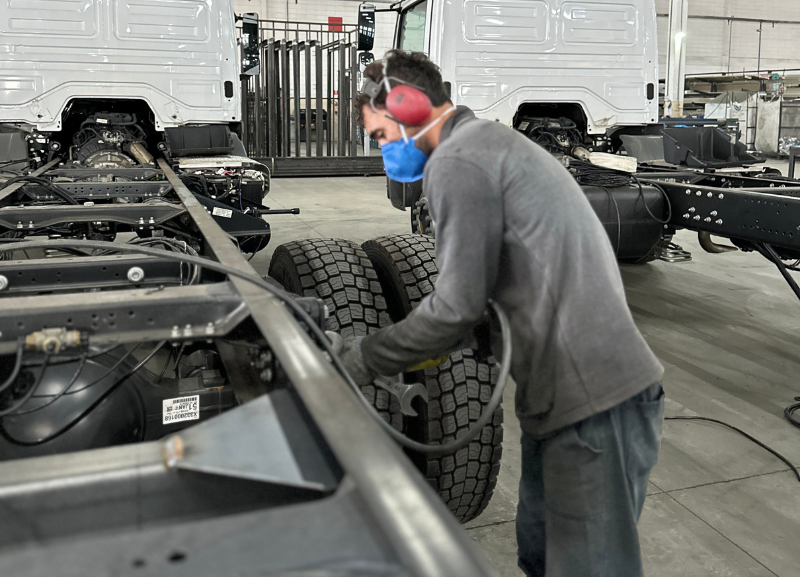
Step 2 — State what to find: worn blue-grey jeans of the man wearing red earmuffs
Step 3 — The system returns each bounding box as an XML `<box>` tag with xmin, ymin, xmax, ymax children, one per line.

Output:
<box><xmin>517</xmin><ymin>383</ymin><xmax>664</xmax><ymax>577</ymax></box>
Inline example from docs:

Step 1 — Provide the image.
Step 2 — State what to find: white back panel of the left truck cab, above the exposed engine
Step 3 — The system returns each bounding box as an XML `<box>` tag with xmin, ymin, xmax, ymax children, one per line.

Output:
<box><xmin>0</xmin><ymin>0</ymin><xmax>241</xmax><ymax>132</ymax></box>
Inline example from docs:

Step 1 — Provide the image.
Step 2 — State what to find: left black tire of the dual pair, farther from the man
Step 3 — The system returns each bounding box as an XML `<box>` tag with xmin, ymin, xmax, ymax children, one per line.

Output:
<box><xmin>269</xmin><ymin>238</ymin><xmax>402</xmax><ymax>427</ymax></box>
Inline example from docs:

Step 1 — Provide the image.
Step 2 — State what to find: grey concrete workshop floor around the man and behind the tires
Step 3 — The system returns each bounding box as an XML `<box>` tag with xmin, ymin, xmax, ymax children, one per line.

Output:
<box><xmin>254</xmin><ymin>172</ymin><xmax>800</xmax><ymax>577</ymax></box>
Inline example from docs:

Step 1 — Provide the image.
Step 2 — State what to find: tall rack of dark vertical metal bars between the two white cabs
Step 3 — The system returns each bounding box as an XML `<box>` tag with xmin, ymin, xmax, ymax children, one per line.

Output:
<box><xmin>234</xmin><ymin>20</ymin><xmax>361</xmax><ymax>166</ymax></box>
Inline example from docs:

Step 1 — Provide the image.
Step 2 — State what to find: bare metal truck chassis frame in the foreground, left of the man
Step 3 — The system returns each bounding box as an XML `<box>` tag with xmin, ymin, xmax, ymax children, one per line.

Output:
<box><xmin>0</xmin><ymin>161</ymin><xmax>493</xmax><ymax>577</ymax></box>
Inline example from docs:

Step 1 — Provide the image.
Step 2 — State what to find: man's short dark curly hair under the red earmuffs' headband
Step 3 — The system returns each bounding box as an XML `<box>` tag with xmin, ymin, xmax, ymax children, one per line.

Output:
<box><xmin>354</xmin><ymin>50</ymin><xmax>450</xmax><ymax>124</ymax></box>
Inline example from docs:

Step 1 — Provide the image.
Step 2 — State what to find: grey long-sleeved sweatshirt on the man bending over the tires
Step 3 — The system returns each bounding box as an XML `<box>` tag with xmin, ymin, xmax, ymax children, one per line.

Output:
<box><xmin>362</xmin><ymin>106</ymin><xmax>664</xmax><ymax>436</ymax></box>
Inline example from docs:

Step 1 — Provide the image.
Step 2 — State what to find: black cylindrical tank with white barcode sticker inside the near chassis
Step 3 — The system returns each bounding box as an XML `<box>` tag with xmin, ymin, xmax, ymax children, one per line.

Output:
<box><xmin>0</xmin><ymin>342</ymin><xmax>236</xmax><ymax>461</ymax></box>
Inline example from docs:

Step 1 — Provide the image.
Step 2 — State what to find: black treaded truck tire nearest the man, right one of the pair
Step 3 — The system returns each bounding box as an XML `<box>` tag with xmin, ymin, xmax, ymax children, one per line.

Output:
<box><xmin>362</xmin><ymin>234</ymin><xmax>503</xmax><ymax>523</ymax></box>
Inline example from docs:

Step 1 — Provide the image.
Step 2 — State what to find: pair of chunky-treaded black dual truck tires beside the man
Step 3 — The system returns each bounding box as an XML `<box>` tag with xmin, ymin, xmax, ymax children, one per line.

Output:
<box><xmin>269</xmin><ymin>234</ymin><xmax>503</xmax><ymax>523</ymax></box>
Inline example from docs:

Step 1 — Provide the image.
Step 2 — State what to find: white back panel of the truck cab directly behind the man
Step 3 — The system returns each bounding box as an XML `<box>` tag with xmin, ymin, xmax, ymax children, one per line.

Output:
<box><xmin>398</xmin><ymin>0</ymin><xmax>658</xmax><ymax>134</ymax></box>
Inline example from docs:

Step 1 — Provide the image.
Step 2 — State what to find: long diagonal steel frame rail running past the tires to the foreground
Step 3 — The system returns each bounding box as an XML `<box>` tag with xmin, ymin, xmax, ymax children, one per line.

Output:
<box><xmin>159</xmin><ymin>160</ymin><xmax>494</xmax><ymax>577</ymax></box>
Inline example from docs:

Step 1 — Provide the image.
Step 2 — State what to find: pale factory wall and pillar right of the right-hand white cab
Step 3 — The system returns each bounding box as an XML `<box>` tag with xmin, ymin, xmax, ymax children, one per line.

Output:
<box><xmin>656</xmin><ymin>0</ymin><xmax>800</xmax><ymax>77</ymax></box>
